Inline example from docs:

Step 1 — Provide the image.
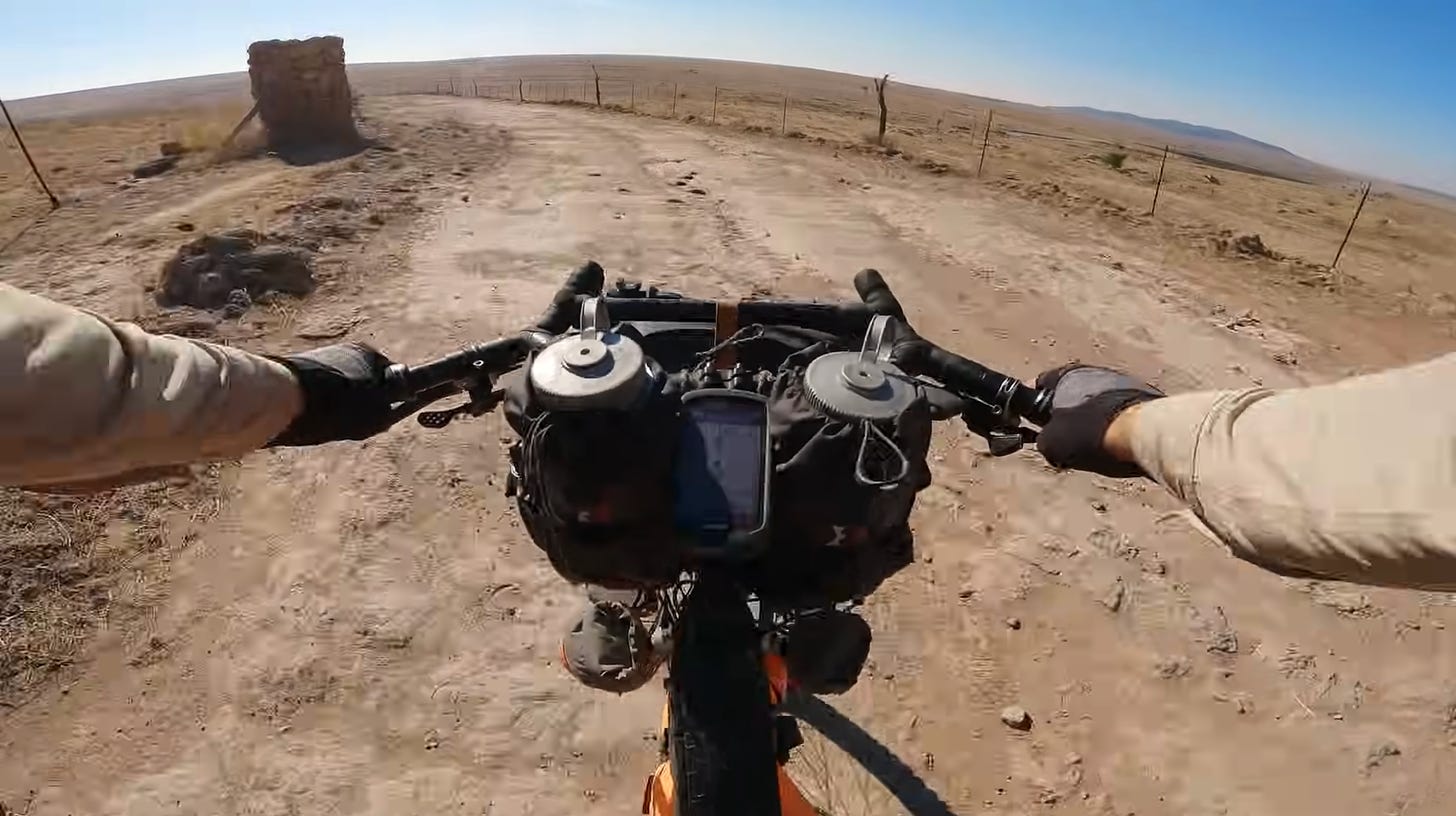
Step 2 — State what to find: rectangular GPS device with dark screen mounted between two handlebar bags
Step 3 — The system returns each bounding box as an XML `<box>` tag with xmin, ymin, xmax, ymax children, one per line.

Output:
<box><xmin>673</xmin><ymin>389</ymin><xmax>770</xmax><ymax>558</ymax></box>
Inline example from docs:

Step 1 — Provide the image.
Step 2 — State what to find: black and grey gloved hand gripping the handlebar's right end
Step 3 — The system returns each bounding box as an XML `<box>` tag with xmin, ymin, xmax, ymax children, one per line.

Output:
<box><xmin>1037</xmin><ymin>363</ymin><xmax>1163</xmax><ymax>476</ymax></box>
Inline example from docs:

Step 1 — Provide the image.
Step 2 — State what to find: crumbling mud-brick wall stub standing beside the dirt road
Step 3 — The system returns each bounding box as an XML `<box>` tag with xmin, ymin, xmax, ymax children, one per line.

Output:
<box><xmin>248</xmin><ymin>36</ymin><xmax>358</xmax><ymax>150</ymax></box>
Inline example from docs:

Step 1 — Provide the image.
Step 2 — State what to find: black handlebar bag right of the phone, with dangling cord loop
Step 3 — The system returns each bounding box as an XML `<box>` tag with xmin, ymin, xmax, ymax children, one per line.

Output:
<box><xmin>748</xmin><ymin>344</ymin><xmax>930</xmax><ymax>608</ymax></box>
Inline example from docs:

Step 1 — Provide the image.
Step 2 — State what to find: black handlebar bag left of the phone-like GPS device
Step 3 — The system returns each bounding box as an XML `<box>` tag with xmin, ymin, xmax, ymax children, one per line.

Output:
<box><xmin>505</xmin><ymin>363</ymin><xmax>683</xmax><ymax>589</ymax></box>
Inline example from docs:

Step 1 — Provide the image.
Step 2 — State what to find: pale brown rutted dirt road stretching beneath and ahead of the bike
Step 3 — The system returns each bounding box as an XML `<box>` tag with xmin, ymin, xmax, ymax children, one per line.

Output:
<box><xmin>0</xmin><ymin>98</ymin><xmax>1456</xmax><ymax>816</ymax></box>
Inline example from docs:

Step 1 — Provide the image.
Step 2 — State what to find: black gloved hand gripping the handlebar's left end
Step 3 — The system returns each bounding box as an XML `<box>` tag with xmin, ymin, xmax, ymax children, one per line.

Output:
<box><xmin>268</xmin><ymin>342</ymin><xmax>397</xmax><ymax>447</ymax></box>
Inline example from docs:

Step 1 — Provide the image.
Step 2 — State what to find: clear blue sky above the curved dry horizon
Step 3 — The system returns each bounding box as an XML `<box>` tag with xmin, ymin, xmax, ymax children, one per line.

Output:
<box><xmin>0</xmin><ymin>0</ymin><xmax>1456</xmax><ymax>192</ymax></box>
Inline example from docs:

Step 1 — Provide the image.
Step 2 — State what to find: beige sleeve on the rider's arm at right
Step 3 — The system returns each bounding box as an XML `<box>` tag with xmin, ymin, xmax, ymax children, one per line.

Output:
<box><xmin>1131</xmin><ymin>354</ymin><xmax>1456</xmax><ymax>590</ymax></box>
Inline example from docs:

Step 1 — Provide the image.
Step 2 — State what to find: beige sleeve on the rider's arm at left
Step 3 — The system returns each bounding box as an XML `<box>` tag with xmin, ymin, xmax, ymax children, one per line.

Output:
<box><xmin>0</xmin><ymin>284</ymin><xmax>303</xmax><ymax>485</ymax></box>
